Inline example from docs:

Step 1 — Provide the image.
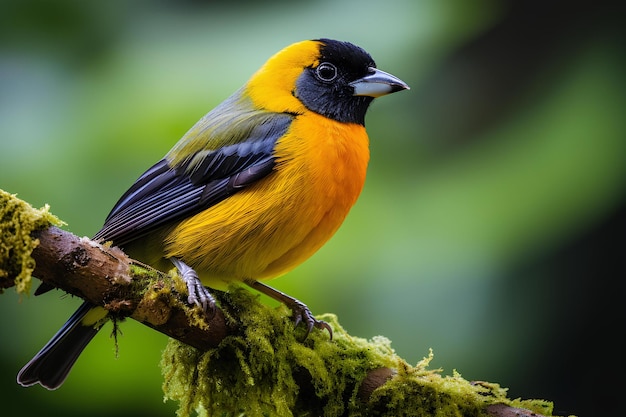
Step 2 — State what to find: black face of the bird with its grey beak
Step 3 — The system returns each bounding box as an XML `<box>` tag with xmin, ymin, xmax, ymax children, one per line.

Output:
<box><xmin>294</xmin><ymin>39</ymin><xmax>408</xmax><ymax>125</ymax></box>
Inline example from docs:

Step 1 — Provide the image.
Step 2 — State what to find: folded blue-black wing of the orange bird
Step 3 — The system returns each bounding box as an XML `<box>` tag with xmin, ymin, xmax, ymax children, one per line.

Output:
<box><xmin>94</xmin><ymin>115</ymin><xmax>292</xmax><ymax>247</ymax></box>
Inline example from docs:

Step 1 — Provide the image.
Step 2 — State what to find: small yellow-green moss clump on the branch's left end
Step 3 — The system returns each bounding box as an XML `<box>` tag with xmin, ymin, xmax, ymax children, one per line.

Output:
<box><xmin>0</xmin><ymin>190</ymin><xmax>64</xmax><ymax>294</ymax></box>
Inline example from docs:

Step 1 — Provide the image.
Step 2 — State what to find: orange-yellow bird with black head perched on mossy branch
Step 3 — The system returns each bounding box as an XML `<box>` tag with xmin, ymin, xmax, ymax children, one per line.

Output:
<box><xmin>17</xmin><ymin>38</ymin><xmax>409</xmax><ymax>390</ymax></box>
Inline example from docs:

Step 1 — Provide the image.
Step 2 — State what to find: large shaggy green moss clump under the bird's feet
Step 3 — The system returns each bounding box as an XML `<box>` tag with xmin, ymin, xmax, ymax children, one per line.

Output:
<box><xmin>161</xmin><ymin>288</ymin><xmax>552</xmax><ymax>417</ymax></box>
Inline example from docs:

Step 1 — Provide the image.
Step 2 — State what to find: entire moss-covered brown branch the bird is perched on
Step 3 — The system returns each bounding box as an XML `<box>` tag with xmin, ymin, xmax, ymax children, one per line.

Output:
<box><xmin>0</xmin><ymin>190</ymin><xmax>568</xmax><ymax>417</ymax></box>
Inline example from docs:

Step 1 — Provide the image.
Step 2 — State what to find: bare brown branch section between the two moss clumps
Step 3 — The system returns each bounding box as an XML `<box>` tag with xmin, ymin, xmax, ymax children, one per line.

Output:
<box><xmin>32</xmin><ymin>227</ymin><xmax>233</xmax><ymax>350</ymax></box>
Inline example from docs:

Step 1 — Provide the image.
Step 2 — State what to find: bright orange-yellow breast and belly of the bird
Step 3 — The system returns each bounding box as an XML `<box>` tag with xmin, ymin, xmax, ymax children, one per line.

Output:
<box><xmin>165</xmin><ymin>112</ymin><xmax>369</xmax><ymax>288</ymax></box>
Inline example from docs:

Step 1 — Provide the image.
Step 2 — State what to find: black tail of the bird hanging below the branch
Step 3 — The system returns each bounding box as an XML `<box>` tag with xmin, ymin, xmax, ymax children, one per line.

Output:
<box><xmin>17</xmin><ymin>302</ymin><xmax>107</xmax><ymax>390</ymax></box>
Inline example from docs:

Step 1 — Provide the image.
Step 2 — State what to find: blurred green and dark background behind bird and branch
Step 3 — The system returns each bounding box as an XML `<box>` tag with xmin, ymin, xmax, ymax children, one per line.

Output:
<box><xmin>0</xmin><ymin>0</ymin><xmax>626</xmax><ymax>417</ymax></box>
